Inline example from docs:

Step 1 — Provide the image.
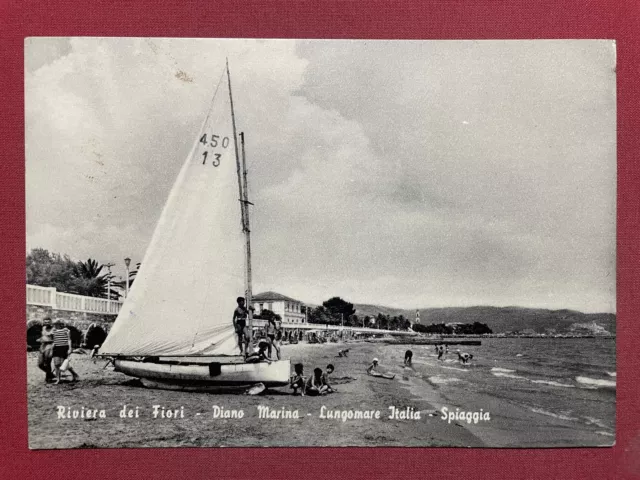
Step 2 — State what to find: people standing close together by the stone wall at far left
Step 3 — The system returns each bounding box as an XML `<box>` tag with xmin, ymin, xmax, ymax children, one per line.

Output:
<box><xmin>38</xmin><ymin>317</ymin><xmax>80</xmax><ymax>384</ymax></box>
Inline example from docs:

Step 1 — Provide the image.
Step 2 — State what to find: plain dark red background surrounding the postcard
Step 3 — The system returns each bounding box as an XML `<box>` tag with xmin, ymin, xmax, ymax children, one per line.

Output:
<box><xmin>0</xmin><ymin>0</ymin><xmax>640</xmax><ymax>479</ymax></box>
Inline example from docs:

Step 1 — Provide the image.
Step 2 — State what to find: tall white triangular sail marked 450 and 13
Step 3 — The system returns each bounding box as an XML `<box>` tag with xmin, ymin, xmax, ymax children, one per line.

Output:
<box><xmin>100</xmin><ymin>66</ymin><xmax>245</xmax><ymax>355</ymax></box>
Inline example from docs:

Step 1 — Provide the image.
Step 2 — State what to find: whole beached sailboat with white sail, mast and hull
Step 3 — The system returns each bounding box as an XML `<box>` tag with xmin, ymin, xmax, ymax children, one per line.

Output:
<box><xmin>100</xmin><ymin>61</ymin><xmax>290</xmax><ymax>391</ymax></box>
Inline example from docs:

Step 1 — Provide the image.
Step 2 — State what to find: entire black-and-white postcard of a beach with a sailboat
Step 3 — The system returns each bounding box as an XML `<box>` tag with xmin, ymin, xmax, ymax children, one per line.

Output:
<box><xmin>25</xmin><ymin>38</ymin><xmax>616</xmax><ymax>449</ymax></box>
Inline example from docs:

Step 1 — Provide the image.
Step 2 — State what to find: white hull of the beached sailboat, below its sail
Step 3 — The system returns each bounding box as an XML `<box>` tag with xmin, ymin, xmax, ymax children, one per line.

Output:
<box><xmin>114</xmin><ymin>359</ymin><xmax>291</xmax><ymax>392</ymax></box>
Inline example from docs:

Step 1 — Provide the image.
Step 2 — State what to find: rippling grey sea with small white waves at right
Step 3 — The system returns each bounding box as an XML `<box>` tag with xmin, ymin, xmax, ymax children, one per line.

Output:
<box><xmin>389</xmin><ymin>338</ymin><xmax>616</xmax><ymax>440</ymax></box>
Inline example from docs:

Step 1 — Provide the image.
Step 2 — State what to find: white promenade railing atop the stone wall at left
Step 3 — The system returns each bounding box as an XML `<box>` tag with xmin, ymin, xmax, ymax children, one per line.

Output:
<box><xmin>27</xmin><ymin>285</ymin><xmax>122</xmax><ymax>315</ymax></box>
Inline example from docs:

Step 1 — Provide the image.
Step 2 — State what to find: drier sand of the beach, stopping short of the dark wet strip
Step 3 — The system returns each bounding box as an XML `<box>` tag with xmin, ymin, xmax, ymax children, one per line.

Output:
<box><xmin>28</xmin><ymin>343</ymin><xmax>483</xmax><ymax>449</ymax></box>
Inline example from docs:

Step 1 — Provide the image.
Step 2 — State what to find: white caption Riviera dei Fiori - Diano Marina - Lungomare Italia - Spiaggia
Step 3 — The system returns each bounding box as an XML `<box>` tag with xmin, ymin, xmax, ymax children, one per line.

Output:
<box><xmin>56</xmin><ymin>405</ymin><xmax>491</xmax><ymax>423</ymax></box>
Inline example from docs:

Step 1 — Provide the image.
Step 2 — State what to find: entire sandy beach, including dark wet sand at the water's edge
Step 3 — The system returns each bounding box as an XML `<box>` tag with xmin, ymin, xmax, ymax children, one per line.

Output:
<box><xmin>28</xmin><ymin>342</ymin><xmax>614</xmax><ymax>449</ymax></box>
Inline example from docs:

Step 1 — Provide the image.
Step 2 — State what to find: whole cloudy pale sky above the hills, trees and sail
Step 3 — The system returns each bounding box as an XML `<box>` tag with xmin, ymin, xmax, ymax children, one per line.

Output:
<box><xmin>25</xmin><ymin>38</ymin><xmax>616</xmax><ymax>312</ymax></box>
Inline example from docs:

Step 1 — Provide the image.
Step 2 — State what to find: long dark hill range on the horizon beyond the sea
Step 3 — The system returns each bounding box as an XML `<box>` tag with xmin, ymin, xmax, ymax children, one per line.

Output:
<box><xmin>354</xmin><ymin>304</ymin><xmax>616</xmax><ymax>335</ymax></box>
